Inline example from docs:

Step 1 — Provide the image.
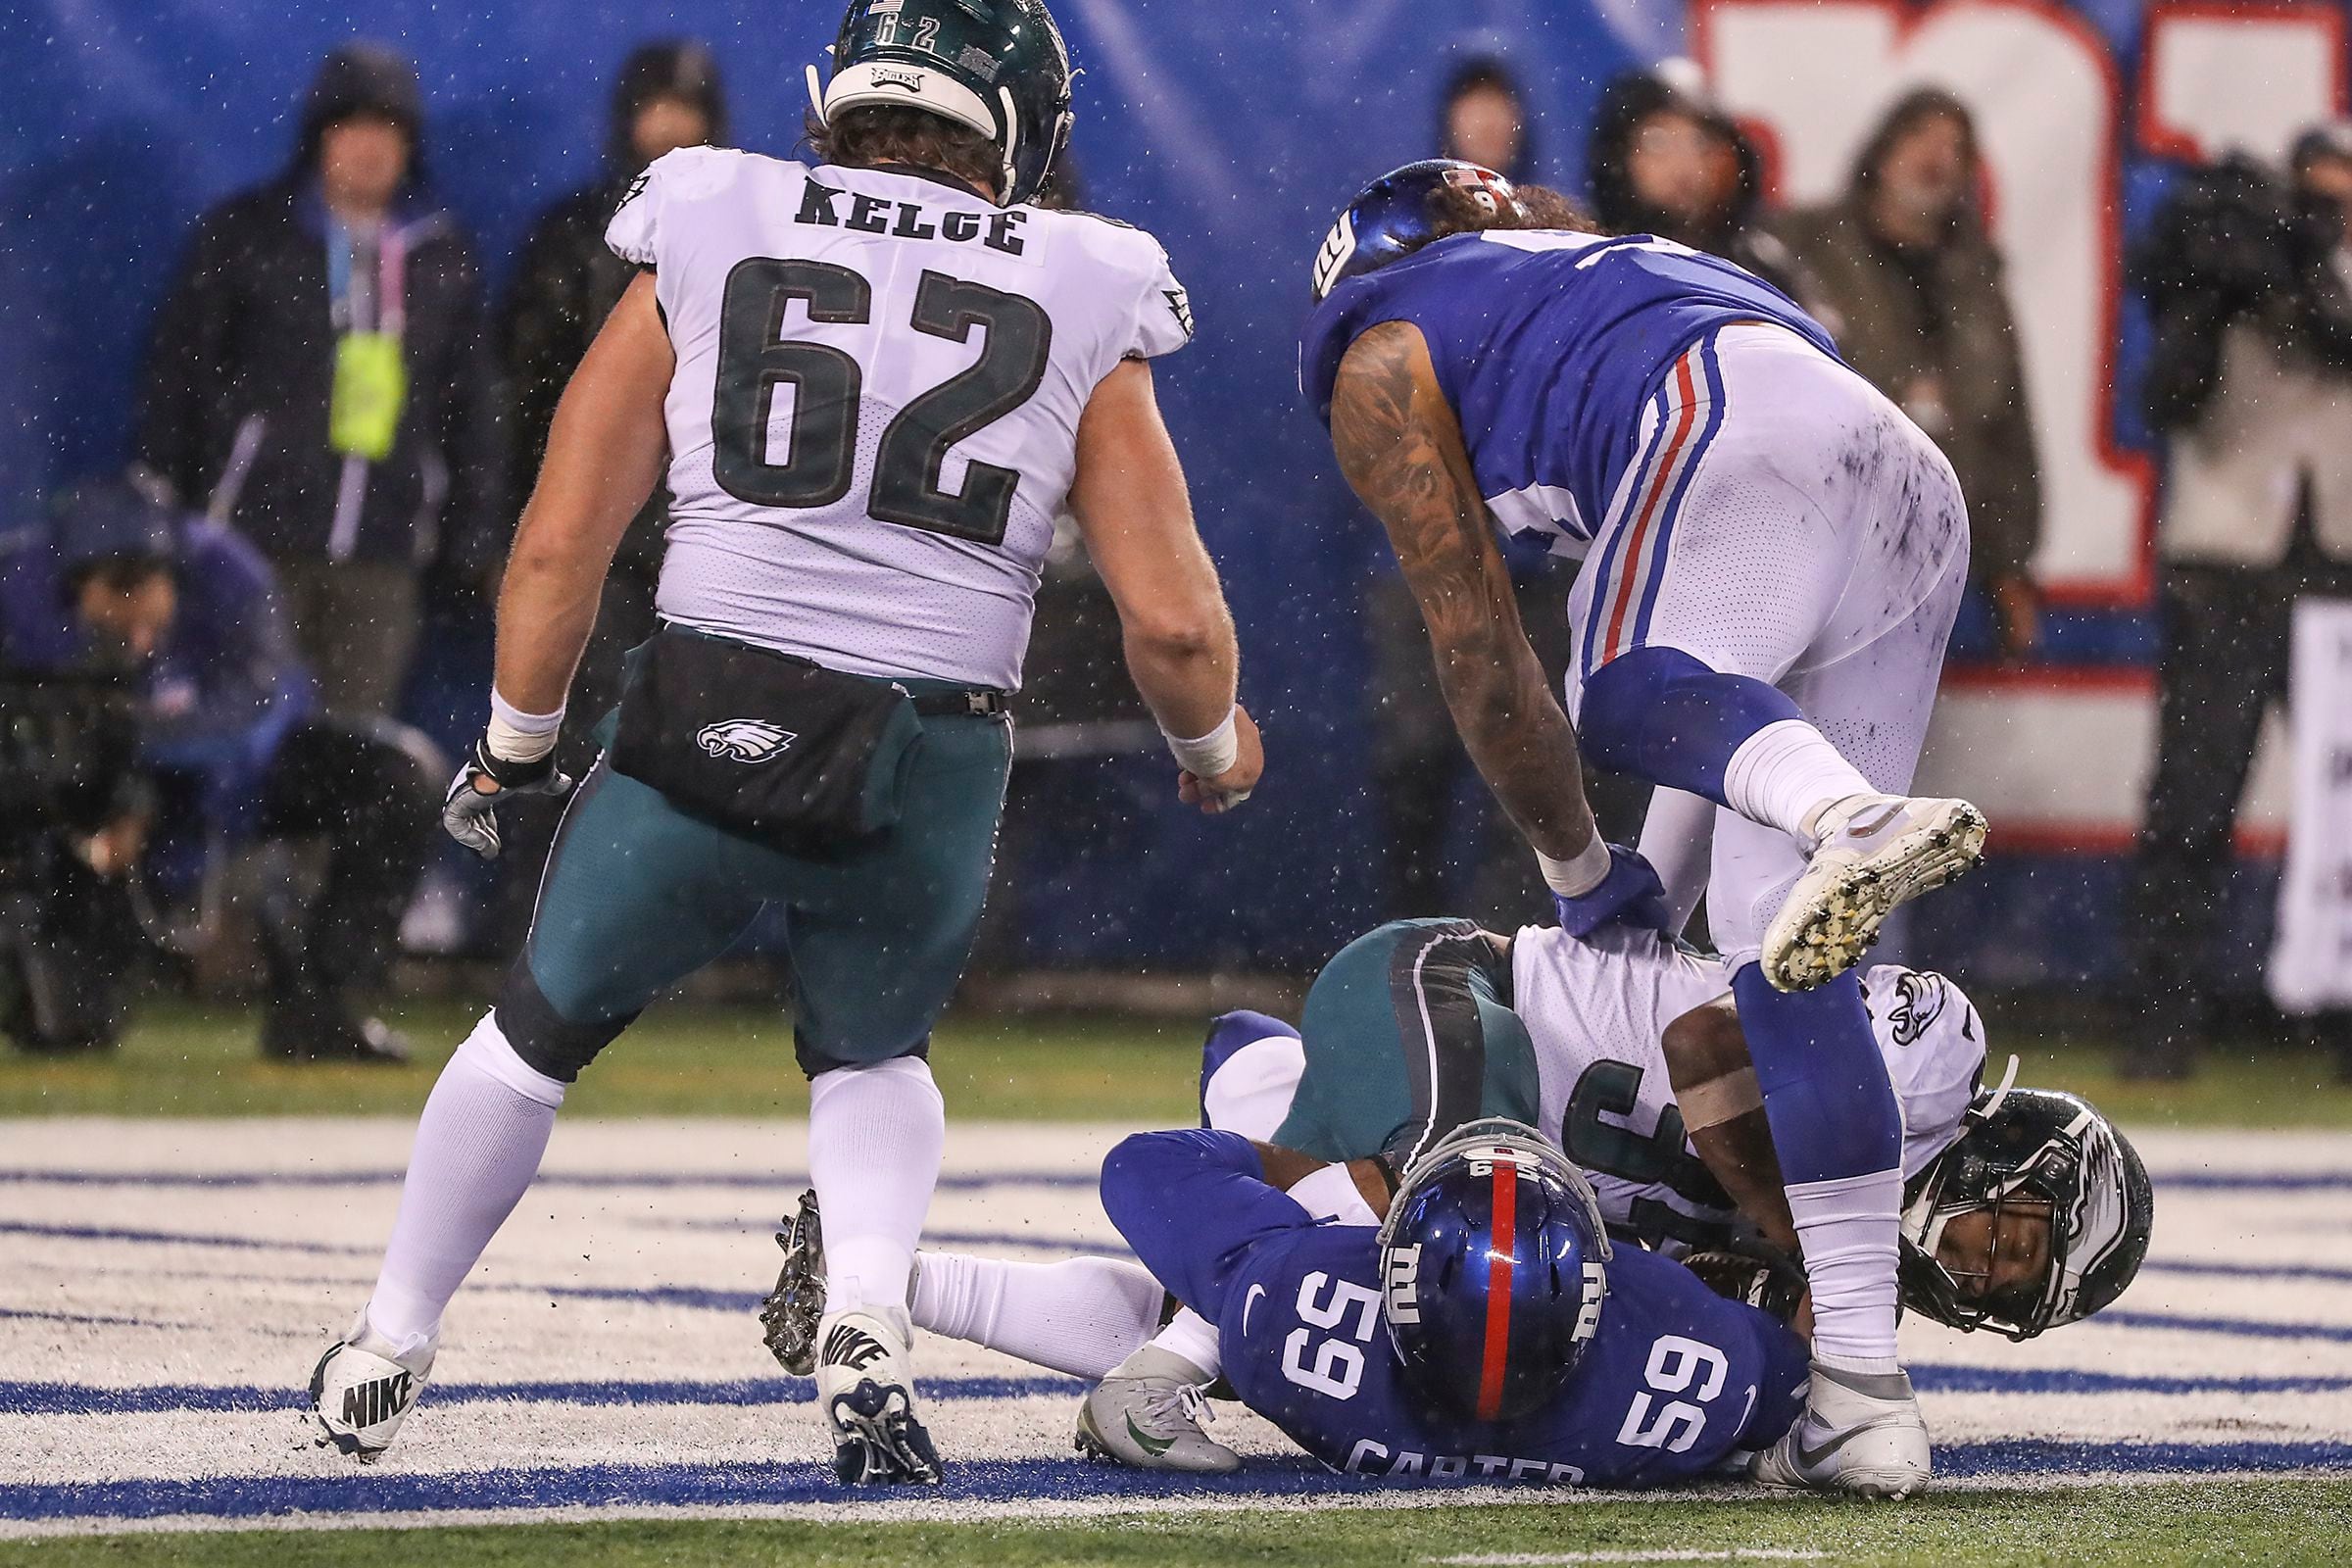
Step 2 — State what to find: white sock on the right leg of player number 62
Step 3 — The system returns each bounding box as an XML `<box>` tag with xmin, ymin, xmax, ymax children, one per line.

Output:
<box><xmin>809</xmin><ymin>1055</ymin><xmax>948</xmax><ymax>1312</ymax></box>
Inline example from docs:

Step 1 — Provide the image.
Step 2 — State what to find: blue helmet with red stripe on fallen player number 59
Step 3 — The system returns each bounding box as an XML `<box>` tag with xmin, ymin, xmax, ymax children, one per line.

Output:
<box><xmin>1381</xmin><ymin>1116</ymin><xmax>1609</xmax><ymax>1420</ymax></box>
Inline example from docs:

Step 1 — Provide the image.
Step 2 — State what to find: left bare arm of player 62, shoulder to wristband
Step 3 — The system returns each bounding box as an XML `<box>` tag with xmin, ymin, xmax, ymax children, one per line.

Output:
<box><xmin>496</xmin><ymin>272</ymin><xmax>677</xmax><ymax>712</ymax></box>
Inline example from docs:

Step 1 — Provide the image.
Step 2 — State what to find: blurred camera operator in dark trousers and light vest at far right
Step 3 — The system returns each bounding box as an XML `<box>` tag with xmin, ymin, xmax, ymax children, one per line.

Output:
<box><xmin>2122</xmin><ymin>122</ymin><xmax>2352</xmax><ymax>1077</ymax></box>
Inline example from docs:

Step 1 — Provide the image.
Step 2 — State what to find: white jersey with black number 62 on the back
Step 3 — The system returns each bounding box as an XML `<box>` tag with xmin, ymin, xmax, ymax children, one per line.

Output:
<box><xmin>605</xmin><ymin>148</ymin><xmax>1193</xmax><ymax>691</ymax></box>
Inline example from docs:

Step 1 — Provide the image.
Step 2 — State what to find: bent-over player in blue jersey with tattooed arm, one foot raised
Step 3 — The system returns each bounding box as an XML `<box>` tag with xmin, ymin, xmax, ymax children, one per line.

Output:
<box><xmin>1300</xmin><ymin>163</ymin><xmax>1985</xmax><ymax>1495</ymax></box>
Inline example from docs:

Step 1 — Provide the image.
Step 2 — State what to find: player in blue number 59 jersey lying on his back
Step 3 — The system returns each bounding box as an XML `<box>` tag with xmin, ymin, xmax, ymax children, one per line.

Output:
<box><xmin>769</xmin><ymin>1119</ymin><xmax>1806</xmax><ymax>1488</ymax></box>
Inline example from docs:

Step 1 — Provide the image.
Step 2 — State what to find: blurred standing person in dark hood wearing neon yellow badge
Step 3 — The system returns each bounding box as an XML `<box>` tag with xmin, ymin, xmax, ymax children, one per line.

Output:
<box><xmin>136</xmin><ymin>45</ymin><xmax>499</xmax><ymax>714</ymax></box>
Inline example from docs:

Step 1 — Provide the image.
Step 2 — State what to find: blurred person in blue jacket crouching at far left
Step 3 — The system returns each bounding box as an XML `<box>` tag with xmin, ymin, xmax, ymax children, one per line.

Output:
<box><xmin>12</xmin><ymin>487</ymin><xmax>440</xmax><ymax>1060</ymax></box>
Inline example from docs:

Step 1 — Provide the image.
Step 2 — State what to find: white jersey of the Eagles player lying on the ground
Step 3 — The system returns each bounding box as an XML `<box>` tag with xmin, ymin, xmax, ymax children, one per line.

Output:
<box><xmin>1510</xmin><ymin>926</ymin><xmax>1985</xmax><ymax>1253</ymax></box>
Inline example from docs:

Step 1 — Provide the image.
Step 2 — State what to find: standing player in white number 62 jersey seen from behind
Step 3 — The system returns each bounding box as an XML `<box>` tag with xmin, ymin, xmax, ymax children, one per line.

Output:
<box><xmin>326</xmin><ymin>0</ymin><xmax>1263</xmax><ymax>1481</ymax></box>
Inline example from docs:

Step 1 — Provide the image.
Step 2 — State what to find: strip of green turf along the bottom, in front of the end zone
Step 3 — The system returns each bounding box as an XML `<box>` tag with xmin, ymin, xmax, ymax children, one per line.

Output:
<box><xmin>0</xmin><ymin>1476</ymin><xmax>2352</xmax><ymax>1568</ymax></box>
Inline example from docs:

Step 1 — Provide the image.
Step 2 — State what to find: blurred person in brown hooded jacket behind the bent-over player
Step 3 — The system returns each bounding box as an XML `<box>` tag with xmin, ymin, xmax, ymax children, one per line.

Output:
<box><xmin>1781</xmin><ymin>87</ymin><xmax>2041</xmax><ymax>659</ymax></box>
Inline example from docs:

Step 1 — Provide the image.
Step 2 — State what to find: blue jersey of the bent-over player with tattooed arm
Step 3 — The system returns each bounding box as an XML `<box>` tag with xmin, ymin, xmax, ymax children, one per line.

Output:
<box><xmin>1298</xmin><ymin>230</ymin><xmax>1837</xmax><ymax>560</ymax></box>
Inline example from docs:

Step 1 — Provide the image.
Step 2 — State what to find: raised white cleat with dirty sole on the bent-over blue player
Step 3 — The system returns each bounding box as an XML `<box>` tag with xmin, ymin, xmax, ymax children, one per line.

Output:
<box><xmin>1759</xmin><ymin>795</ymin><xmax>1985</xmax><ymax>992</ymax></box>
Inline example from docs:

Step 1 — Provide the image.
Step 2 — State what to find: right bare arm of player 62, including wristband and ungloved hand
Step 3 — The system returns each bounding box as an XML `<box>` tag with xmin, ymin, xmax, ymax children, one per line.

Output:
<box><xmin>1070</xmin><ymin>360</ymin><xmax>1265</xmax><ymax>813</ymax></box>
